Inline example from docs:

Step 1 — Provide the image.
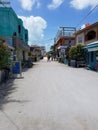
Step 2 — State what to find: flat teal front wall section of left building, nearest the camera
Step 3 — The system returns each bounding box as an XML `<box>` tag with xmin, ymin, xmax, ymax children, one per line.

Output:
<box><xmin>0</xmin><ymin>7</ymin><xmax>18</xmax><ymax>36</ymax></box>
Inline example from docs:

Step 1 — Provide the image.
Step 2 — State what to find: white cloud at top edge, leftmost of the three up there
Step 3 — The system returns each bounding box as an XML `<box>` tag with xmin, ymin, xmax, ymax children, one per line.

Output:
<box><xmin>18</xmin><ymin>0</ymin><xmax>40</xmax><ymax>11</ymax></box>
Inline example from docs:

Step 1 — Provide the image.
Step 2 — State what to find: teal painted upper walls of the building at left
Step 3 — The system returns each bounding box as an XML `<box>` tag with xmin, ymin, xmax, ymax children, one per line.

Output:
<box><xmin>0</xmin><ymin>7</ymin><xmax>28</xmax><ymax>44</ymax></box>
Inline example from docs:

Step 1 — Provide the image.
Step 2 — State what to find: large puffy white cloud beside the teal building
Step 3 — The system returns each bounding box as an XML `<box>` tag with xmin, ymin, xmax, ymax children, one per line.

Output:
<box><xmin>19</xmin><ymin>16</ymin><xmax>47</xmax><ymax>44</ymax></box>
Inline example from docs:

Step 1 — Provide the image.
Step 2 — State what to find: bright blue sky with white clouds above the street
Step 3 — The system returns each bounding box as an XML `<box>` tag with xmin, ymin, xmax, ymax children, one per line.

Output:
<box><xmin>9</xmin><ymin>0</ymin><xmax>98</xmax><ymax>50</ymax></box>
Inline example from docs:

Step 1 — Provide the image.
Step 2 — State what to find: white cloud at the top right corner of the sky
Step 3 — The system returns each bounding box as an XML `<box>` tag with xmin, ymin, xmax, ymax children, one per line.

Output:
<box><xmin>70</xmin><ymin>0</ymin><xmax>98</xmax><ymax>10</ymax></box>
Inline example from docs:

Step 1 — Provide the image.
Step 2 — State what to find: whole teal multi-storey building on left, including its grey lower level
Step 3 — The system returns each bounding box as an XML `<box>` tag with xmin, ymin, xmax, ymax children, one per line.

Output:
<box><xmin>0</xmin><ymin>7</ymin><xmax>30</xmax><ymax>61</ymax></box>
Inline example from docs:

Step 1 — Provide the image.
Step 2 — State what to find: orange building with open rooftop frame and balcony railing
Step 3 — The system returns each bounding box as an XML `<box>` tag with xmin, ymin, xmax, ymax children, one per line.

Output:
<box><xmin>54</xmin><ymin>27</ymin><xmax>76</xmax><ymax>60</ymax></box>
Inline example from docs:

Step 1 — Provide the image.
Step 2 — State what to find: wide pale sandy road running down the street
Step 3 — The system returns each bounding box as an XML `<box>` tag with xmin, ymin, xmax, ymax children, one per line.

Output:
<box><xmin>0</xmin><ymin>59</ymin><xmax>98</xmax><ymax>130</ymax></box>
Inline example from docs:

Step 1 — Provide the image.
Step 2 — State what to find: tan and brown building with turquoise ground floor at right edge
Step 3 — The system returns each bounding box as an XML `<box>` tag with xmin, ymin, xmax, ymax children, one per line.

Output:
<box><xmin>76</xmin><ymin>22</ymin><xmax>98</xmax><ymax>69</ymax></box>
